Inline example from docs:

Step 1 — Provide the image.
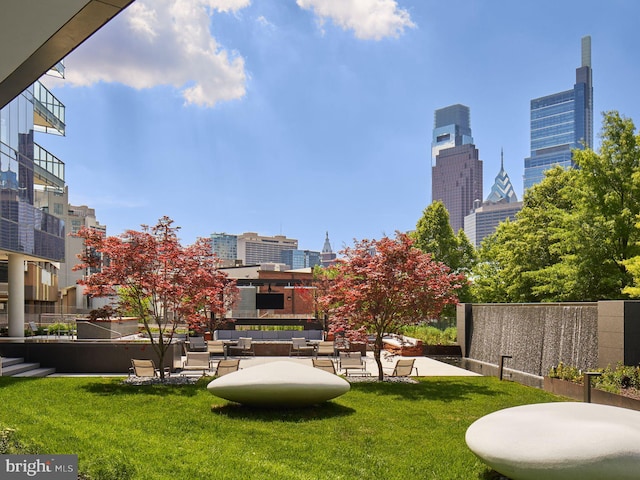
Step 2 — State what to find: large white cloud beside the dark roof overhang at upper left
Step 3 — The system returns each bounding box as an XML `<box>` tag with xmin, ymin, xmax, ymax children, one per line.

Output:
<box><xmin>61</xmin><ymin>0</ymin><xmax>250</xmax><ymax>107</ymax></box>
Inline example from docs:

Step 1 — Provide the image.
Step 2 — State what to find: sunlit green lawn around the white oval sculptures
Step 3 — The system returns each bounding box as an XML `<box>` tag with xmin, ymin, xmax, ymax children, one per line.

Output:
<box><xmin>0</xmin><ymin>377</ymin><xmax>561</xmax><ymax>480</ymax></box>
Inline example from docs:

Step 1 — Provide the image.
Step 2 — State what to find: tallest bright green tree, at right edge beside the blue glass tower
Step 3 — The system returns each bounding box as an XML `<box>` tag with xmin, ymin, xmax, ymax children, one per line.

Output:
<box><xmin>574</xmin><ymin>111</ymin><xmax>640</xmax><ymax>298</ymax></box>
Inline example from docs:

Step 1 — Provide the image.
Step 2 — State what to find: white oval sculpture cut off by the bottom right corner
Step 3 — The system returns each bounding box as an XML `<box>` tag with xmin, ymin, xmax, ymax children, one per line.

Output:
<box><xmin>466</xmin><ymin>402</ymin><xmax>640</xmax><ymax>480</ymax></box>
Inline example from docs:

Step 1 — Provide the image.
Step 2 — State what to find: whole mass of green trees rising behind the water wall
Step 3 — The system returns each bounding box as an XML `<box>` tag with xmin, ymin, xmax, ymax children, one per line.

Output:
<box><xmin>472</xmin><ymin>112</ymin><xmax>640</xmax><ymax>302</ymax></box>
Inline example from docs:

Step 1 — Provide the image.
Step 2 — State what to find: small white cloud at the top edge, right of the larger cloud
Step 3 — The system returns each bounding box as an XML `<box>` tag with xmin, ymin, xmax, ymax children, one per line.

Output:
<box><xmin>297</xmin><ymin>0</ymin><xmax>415</xmax><ymax>40</ymax></box>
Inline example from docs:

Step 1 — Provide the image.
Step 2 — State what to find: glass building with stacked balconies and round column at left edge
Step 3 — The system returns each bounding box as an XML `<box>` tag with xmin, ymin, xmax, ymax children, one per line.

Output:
<box><xmin>0</xmin><ymin>75</ymin><xmax>65</xmax><ymax>337</ymax></box>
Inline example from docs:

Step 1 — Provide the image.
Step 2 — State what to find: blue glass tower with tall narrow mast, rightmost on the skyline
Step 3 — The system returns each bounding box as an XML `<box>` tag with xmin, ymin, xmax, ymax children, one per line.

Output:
<box><xmin>523</xmin><ymin>36</ymin><xmax>593</xmax><ymax>191</ymax></box>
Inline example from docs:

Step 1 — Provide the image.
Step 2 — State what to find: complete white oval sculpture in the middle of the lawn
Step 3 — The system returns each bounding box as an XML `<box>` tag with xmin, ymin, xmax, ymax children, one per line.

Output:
<box><xmin>207</xmin><ymin>361</ymin><xmax>351</xmax><ymax>406</ymax></box>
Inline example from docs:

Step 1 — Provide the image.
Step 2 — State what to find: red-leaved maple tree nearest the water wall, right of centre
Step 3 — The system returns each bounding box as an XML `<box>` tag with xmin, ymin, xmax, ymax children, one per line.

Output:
<box><xmin>320</xmin><ymin>233</ymin><xmax>466</xmax><ymax>380</ymax></box>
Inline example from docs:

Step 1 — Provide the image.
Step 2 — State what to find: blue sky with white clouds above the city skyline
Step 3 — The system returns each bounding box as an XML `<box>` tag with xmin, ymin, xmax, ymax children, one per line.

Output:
<box><xmin>38</xmin><ymin>0</ymin><xmax>640</xmax><ymax>251</ymax></box>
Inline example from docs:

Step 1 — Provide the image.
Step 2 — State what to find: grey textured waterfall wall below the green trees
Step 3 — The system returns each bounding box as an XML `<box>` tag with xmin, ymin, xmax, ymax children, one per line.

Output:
<box><xmin>458</xmin><ymin>303</ymin><xmax>598</xmax><ymax>377</ymax></box>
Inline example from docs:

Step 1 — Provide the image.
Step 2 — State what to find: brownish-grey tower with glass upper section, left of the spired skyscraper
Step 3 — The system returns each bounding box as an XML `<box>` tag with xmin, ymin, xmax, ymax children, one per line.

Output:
<box><xmin>431</xmin><ymin>105</ymin><xmax>482</xmax><ymax>232</ymax></box>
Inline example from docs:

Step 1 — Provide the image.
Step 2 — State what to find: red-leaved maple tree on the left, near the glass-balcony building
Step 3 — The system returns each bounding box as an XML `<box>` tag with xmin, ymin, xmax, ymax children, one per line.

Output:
<box><xmin>74</xmin><ymin>216</ymin><xmax>236</xmax><ymax>378</ymax></box>
